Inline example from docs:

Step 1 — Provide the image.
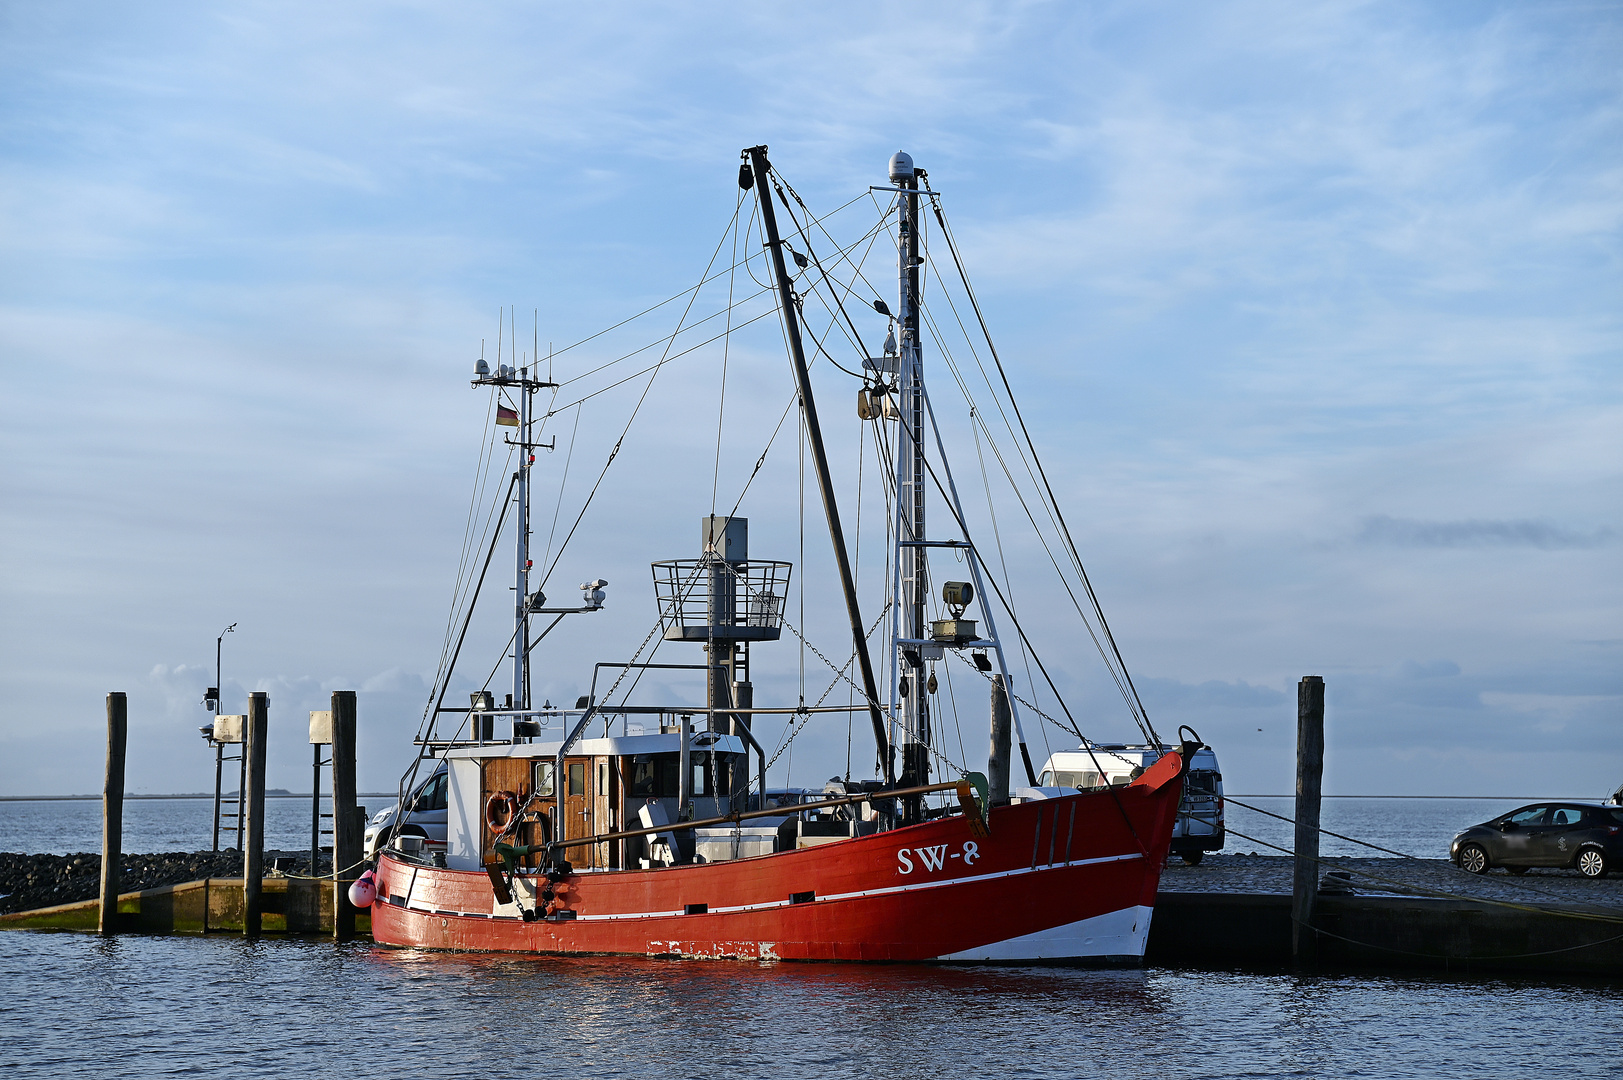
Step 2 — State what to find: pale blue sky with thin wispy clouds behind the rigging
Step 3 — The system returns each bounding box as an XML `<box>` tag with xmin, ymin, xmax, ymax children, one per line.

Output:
<box><xmin>0</xmin><ymin>2</ymin><xmax>1623</xmax><ymax>797</ymax></box>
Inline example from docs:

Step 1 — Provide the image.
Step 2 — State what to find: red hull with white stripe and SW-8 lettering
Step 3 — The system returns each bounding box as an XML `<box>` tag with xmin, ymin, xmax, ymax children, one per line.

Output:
<box><xmin>372</xmin><ymin>762</ymin><xmax>1182</xmax><ymax>963</ymax></box>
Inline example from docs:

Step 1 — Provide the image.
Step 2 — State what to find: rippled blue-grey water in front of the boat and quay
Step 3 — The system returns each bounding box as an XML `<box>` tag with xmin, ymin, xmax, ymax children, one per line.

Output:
<box><xmin>0</xmin><ymin>932</ymin><xmax>1623</xmax><ymax>1080</ymax></box>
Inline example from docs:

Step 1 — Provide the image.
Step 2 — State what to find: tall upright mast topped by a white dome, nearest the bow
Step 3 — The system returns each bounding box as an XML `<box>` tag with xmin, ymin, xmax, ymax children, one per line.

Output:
<box><xmin>889</xmin><ymin>151</ymin><xmax>930</xmax><ymax>822</ymax></box>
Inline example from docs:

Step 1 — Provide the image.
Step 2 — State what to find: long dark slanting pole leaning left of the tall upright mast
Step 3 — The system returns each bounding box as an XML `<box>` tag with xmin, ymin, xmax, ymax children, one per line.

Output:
<box><xmin>738</xmin><ymin>146</ymin><xmax>896</xmax><ymax>788</ymax></box>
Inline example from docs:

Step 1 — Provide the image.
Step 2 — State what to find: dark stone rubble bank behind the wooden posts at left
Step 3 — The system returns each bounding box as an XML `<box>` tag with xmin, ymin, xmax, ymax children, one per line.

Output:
<box><xmin>0</xmin><ymin>851</ymin><xmax>331</xmax><ymax>914</ymax></box>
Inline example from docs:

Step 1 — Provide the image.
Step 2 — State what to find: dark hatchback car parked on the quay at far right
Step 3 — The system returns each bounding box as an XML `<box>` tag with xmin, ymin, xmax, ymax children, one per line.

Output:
<box><xmin>1449</xmin><ymin>802</ymin><xmax>1623</xmax><ymax>877</ymax></box>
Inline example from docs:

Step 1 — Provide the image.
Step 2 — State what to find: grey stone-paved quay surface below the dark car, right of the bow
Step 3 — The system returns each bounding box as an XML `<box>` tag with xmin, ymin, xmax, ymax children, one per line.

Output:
<box><xmin>1160</xmin><ymin>854</ymin><xmax>1623</xmax><ymax>908</ymax></box>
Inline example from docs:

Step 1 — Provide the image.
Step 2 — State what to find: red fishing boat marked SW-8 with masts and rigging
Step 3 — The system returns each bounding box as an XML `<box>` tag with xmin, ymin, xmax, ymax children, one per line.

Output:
<box><xmin>368</xmin><ymin>146</ymin><xmax>1199</xmax><ymax>963</ymax></box>
